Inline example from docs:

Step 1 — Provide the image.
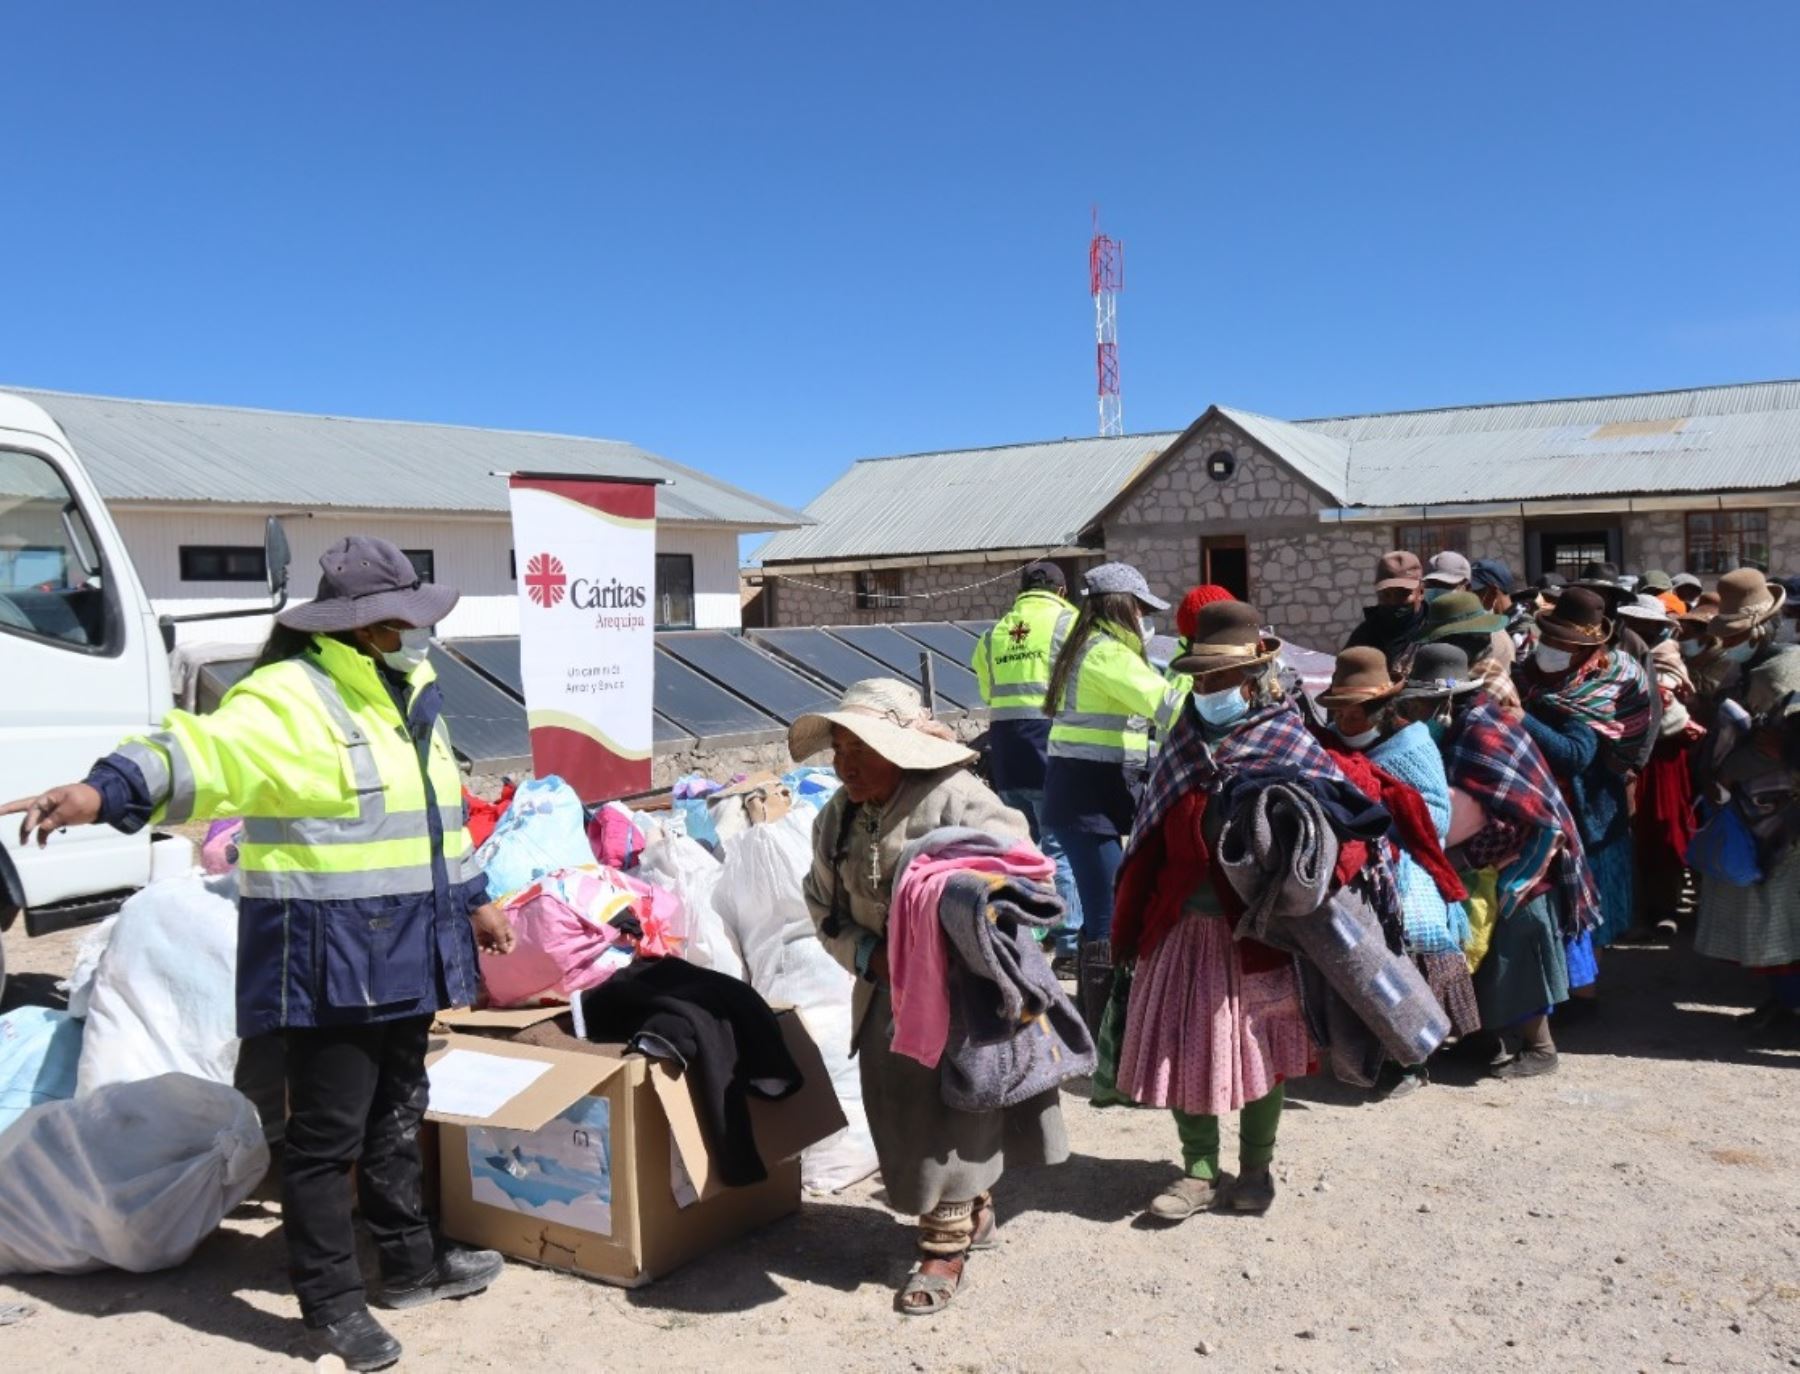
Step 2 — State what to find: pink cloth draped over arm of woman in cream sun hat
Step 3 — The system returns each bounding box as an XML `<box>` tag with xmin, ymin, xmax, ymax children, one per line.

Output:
<box><xmin>887</xmin><ymin>841</ymin><xmax>1057</xmax><ymax>1068</ymax></box>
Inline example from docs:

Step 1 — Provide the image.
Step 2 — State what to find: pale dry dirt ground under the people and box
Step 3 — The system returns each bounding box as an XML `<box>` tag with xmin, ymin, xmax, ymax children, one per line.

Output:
<box><xmin>0</xmin><ymin>936</ymin><xmax>1800</xmax><ymax>1374</ymax></box>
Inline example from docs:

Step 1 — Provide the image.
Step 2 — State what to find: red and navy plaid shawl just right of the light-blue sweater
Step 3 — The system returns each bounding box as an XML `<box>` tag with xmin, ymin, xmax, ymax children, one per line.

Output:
<box><xmin>1444</xmin><ymin>697</ymin><xmax>1600</xmax><ymax>933</ymax></box>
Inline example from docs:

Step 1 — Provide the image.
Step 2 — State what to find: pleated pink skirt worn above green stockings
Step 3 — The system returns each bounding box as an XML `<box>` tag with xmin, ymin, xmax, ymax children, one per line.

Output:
<box><xmin>1118</xmin><ymin>915</ymin><xmax>1318</xmax><ymax>1116</ymax></box>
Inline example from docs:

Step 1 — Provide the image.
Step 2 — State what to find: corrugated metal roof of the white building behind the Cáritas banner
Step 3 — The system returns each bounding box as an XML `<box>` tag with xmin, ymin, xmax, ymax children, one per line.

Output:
<box><xmin>7</xmin><ymin>387</ymin><xmax>806</xmax><ymax>529</ymax></box>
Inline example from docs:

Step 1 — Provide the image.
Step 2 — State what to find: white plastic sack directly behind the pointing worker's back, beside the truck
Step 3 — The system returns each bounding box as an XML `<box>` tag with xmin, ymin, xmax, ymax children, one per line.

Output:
<box><xmin>76</xmin><ymin>873</ymin><xmax>238</xmax><ymax>1097</ymax></box>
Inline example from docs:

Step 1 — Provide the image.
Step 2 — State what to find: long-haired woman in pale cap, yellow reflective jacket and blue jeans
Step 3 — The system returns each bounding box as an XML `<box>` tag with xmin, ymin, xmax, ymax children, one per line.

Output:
<box><xmin>1042</xmin><ymin>564</ymin><xmax>1168</xmax><ymax>1028</ymax></box>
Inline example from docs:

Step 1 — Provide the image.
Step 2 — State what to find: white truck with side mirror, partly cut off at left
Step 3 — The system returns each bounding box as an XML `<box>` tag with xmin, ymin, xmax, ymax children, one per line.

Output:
<box><xmin>0</xmin><ymin>393</ymin><xmax>288</xmax><ymax>992</ymax></box>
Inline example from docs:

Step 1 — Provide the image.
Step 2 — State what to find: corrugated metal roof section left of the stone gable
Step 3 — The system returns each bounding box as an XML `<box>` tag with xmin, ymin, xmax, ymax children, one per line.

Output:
<box><xmin>756</xmin><ymin>434</ymin><xmax>1177</xmax><ymax>562</ymax></box>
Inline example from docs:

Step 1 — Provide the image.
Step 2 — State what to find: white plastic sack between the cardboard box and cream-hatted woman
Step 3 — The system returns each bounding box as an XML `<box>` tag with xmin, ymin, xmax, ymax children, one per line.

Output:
<box><xmin>713</xmin><ymin>807</ymin><xmax>877</xmax><ymax>1192</ymax></box>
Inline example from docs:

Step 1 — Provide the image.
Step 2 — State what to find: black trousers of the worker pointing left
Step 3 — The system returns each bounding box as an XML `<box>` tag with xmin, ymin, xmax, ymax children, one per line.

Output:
<box><xmin>281</xmin><ymin>1016</ymin><xmax>436</xmax><ymax>1327</ymax></box>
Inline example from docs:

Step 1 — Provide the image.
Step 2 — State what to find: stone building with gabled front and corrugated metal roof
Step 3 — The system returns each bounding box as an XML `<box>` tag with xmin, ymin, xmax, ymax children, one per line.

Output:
<box><xmin>763</xmin><ymin>382</ymin><xmax>1800</xmax><ymax>648</ymax></box>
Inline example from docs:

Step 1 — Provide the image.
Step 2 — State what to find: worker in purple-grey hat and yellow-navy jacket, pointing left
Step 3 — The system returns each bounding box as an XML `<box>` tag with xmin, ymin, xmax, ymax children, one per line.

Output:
<box><xmin>0</xmin><ymin>537</ymin><xmax>513</xmax><ymax>1369</ymax></box>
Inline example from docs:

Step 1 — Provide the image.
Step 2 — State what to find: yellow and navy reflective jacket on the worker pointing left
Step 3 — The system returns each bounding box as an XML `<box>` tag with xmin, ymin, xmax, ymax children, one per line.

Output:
<box><xmin>113</xmin><ymin>636</ymin><xmax>481</xmax><ymax>1034</ymax></box>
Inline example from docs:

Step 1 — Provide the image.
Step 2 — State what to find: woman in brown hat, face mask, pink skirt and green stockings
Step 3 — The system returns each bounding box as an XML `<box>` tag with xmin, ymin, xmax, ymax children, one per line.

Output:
<box><xmin>1112</xmin><ymin>601</ymin><xmax>1343</xmax><ymax>1223</ymax></box>
